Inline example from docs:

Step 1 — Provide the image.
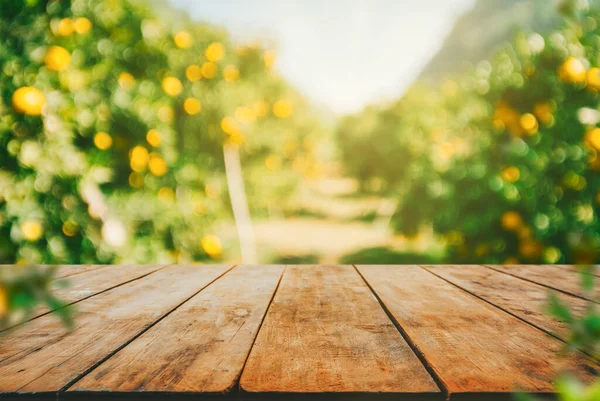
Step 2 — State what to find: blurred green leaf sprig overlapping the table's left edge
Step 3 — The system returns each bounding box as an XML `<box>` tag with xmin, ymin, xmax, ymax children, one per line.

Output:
<box><xmin>0</xmin><ymin>266</ymin><xmax>73</xmax><ymax>330</ymax></box>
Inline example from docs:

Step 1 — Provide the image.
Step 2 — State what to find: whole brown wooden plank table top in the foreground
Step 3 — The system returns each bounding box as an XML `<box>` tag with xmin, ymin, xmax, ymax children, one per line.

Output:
<box><xmin>0</xmin><ymin>265</ymin><xmax>600</xmax><ymax>400</ymax></box>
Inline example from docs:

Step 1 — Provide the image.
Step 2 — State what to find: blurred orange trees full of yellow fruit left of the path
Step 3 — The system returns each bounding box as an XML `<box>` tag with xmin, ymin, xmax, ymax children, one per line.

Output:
<box><xmin>0</xmin><ymin>0</ymin><xmax>323</xmax><ymax>263</ymax></box>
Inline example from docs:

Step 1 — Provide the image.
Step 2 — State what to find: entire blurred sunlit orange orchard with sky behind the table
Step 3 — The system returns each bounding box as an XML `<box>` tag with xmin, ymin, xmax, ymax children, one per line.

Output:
<box><xmin>0</xmin><ymin>0</ymin><xmax>600</xmax><ymax>264</ymax></box>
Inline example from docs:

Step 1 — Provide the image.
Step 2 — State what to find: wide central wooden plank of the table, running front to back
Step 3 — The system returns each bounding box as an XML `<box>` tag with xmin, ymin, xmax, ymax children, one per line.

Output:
<box><xmin>240</xmin><ymin>266</ymin><xmax>439</xmax><ymax>394</ymax></box>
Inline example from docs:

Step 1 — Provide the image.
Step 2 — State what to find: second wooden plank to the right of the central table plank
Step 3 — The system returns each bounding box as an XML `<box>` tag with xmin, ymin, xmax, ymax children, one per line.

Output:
<box><xmin>423</xmin><ymin>265</ymin><xmax>589</xmax><ymax>340</ymax></box>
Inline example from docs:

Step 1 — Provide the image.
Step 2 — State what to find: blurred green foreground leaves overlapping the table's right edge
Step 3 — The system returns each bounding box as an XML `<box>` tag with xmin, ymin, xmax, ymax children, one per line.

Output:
<box><xmin>517</xmin><ymin>266</ymin><xmax>600</xmax><ymax>401</ymax></box>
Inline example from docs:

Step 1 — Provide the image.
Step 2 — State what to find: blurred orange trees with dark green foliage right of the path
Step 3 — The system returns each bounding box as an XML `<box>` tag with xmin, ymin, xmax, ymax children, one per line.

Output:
<box><xmin>337</xmin><ymin>0</ymin><xmax>600</xmax><ymax>264</ymax></box>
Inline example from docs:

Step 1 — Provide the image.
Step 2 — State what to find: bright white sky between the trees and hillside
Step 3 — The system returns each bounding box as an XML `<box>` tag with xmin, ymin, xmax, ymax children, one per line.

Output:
<box><xmin>170</xmin><ymin>0</ymin><xmax>474</xmax><ymax>114</ymax></box>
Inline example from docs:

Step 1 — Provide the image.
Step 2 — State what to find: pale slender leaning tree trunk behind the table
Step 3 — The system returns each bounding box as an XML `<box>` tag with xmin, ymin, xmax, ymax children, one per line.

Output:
<box><xmin>223</xmin><ymin>145</ymin><xmax>258</xmax><ymax>264</ymax></box>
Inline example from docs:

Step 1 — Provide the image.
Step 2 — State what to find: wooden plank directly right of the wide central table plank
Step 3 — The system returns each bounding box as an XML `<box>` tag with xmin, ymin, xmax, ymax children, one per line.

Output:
<box><xmin>358</xmin><ymin>265</ymin><xmax>595</xmax><ymax>399</ymax></box>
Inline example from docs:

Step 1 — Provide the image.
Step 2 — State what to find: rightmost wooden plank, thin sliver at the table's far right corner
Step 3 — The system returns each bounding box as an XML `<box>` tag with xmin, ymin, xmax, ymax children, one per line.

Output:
<box><xmin>485</xmin><ymin>265</ymin><xmax>600</xmax><ymax>302</ymax></box>
